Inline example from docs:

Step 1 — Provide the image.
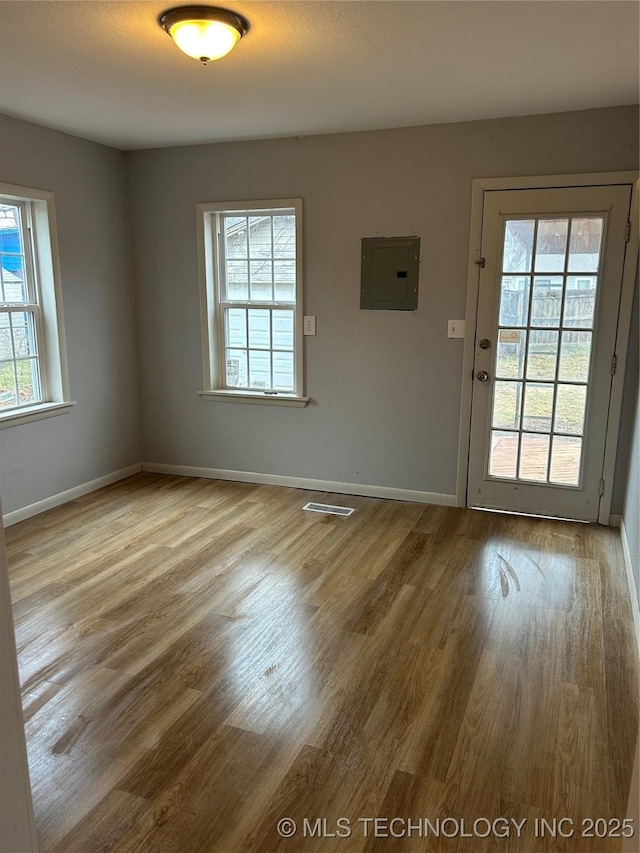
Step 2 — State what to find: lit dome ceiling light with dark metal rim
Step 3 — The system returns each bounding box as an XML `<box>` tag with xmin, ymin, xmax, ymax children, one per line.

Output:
<box><xmin>158</xmin><ymin>6</ymin><xmax>249</xmax><ymax>65</ymax></box>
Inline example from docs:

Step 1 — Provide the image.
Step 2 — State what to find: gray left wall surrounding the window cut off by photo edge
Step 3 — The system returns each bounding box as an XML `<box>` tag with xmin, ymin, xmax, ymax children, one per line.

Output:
<box><xmin>0</xmin><ymin>116</ymin><xmax>140</xmax><ymax>512</ymax></box>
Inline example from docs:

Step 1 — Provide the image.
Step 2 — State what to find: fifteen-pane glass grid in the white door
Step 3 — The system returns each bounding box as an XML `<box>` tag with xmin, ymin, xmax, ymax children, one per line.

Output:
<box><xmin>488</xmin><ymin>216</ymin><xmax>604</xmax><ymax>487</ymax></box>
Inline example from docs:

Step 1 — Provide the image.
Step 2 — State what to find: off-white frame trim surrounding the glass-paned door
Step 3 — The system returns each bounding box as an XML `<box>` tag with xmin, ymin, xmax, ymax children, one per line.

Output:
<box><xmin>456</xmin><ymin>171</ymin><xmax>640</xmax><ymax>524</ymax></box>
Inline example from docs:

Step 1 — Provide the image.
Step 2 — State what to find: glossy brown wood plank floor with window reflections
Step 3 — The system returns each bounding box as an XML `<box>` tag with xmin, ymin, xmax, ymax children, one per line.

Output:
<box><xmin>7</xmin><ymin>474</ymin><xmax>639</xmax><ymax>853</ymax></box>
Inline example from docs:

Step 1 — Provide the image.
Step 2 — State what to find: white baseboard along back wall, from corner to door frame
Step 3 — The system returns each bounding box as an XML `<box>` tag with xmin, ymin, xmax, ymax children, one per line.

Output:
<box><xmin>142</xmin><ymin>462</ymin><xmax>456</xmax><ymax>506</ymax></box>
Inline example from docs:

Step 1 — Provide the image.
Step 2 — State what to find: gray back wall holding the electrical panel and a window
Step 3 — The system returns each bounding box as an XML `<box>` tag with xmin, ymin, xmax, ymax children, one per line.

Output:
<box><xmin>127</xmin><ymin>107</ymin><xmax>638</xmax><ymax>496</ymax></box>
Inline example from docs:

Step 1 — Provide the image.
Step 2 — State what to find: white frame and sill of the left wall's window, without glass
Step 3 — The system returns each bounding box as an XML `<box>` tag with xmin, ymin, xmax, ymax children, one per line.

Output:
<box><xmin>0</xmin><ymin>183</ymin><xmax>74</xmax><ymax>429</ymax></box>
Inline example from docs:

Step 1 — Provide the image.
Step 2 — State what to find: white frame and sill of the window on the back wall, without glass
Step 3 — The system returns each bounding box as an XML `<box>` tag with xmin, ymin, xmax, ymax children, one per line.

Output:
<box><xmin>196</xmin><ymin>198</ymin><xmax>309</xmax><ymax>407</ymax></box>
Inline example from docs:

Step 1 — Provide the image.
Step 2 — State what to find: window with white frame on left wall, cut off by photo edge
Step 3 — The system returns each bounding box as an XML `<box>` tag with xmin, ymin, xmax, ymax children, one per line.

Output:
<box><xmin>0</xmin><ymin>184</ymin><xmax>71</xmax><ymax>427</ymax></box>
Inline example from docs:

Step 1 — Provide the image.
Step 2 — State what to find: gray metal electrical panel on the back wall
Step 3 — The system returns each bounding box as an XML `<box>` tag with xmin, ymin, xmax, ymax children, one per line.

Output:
<box><xmin>360</xmin><ymin>237</ymin><xmax>420</xmax><ymax>311</ymax></box>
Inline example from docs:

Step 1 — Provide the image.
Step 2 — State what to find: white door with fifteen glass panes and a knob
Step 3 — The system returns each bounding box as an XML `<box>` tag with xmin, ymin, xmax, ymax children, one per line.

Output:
<box><xmin>467</xmin><ymin>185</ymin><xmax>631</xmax><ymax>521</ymax></box>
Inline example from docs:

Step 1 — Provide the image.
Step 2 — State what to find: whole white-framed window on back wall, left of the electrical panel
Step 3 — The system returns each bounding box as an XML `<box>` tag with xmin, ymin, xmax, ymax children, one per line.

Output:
<box><xmin>198</xmin><ymin>199</ymin><xmax>308</xmax><ymax>406</ymax></box>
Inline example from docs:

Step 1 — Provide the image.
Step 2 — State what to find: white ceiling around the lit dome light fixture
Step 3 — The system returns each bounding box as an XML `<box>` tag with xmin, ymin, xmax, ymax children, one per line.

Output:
<box><xmin>0</xmin><ymin>0</ymin><xmax>640</xmax><ymax>149</ymax></box>
